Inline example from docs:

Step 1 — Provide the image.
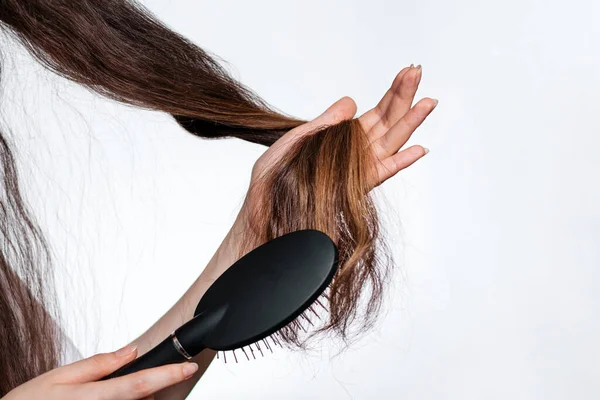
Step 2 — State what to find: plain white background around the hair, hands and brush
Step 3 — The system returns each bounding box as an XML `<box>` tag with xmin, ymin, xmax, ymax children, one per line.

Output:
<box><xmin>2</xmin><ymin>0</ymin><xmax>600</xmax><ymax>399</ymax></box>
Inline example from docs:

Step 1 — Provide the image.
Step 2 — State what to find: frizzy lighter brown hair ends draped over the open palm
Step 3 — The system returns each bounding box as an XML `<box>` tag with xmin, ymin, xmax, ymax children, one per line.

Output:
<box><xmin>240</xmin><ymin>119</ymin><xmax>390</xmax><ymax>347</ymax></box>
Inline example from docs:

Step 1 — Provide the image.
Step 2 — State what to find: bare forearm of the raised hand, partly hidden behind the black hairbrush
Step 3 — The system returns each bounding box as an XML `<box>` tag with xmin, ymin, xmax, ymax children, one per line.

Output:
<box><xmin>128</xmin><ymin>208</ymin><xmax>243</xmax><ymax>400</ymax></box>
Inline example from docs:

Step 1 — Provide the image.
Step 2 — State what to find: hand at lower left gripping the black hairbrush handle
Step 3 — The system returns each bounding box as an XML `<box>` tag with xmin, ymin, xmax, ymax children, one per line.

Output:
<box><xmin>4</xmin><ymin>346</ymin><xmax>198</xmax><ymax>400</ymax></box>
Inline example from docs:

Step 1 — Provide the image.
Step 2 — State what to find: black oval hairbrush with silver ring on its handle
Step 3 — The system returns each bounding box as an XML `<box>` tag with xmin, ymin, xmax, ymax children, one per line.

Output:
<box><xmin>104</xmin><ymin>230</ymin><xmax>338</xmax><ymax>379</ymax></box>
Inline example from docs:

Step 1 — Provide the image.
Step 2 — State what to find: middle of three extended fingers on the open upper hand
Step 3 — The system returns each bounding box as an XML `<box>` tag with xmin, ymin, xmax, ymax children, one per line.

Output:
<box><xmin>374</xmin><ymin>98</ymin><xmax>437</xmax><ymax>160</ymax></box>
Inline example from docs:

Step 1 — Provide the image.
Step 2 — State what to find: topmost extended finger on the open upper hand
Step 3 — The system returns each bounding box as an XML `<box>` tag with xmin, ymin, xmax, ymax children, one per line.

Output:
<box><xmin>360</xmin><ymin>65</ymin><xmax>422</xmax><ymax>139</ymax></box>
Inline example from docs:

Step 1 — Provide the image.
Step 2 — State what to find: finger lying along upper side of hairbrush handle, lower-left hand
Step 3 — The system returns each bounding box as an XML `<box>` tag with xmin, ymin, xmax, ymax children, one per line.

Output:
<box><xmin>56</xmin><ymin>345</ymin><xmax>137</xmax><ymax>383</ymax></box>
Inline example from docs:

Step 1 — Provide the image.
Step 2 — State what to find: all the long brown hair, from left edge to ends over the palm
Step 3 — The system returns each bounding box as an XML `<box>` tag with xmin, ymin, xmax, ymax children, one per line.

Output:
<box><xmin>0</xmin><ymin>0</ymin><xmax>388</xmax><ymax>395</ymax></box>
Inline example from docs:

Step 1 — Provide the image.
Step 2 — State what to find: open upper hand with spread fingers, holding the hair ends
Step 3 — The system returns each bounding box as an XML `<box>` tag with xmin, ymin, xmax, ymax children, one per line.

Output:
<box><xmin>252</xmin><ymin>66</ymin><xmax>437</xmax><ymax>187</ymax></box>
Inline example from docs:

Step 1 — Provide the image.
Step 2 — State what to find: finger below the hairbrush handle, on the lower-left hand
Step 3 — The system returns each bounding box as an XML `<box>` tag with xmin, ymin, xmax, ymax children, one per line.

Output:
<box><xmin>81</xmin><ymin>362</ymin><xmax>198</xmax><ymax>400</ymax></box>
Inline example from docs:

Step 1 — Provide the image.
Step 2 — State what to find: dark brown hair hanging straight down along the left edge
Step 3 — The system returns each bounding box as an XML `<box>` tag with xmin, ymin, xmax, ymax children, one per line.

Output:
<box><xmin>0</xmin><ymin>129</ymin><xmax>62</xmax><ymax>397</ymax></box>
